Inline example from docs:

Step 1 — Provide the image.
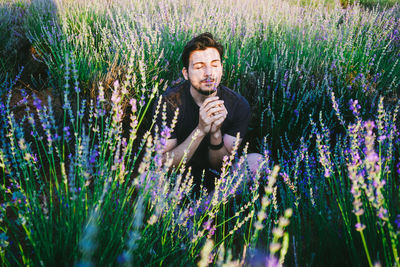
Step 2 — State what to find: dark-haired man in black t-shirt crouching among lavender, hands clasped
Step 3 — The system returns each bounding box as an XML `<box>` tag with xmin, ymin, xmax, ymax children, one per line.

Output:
<box><xmin>157</xmin><ymin>33</ymin><xmax>258</xmax><ymax>192</ymax></box>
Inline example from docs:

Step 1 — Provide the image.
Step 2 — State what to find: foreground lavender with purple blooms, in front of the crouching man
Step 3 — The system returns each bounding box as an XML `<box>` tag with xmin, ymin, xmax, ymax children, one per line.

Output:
<box><xmin>0</xmin><ymin>61</ymin><xmax>400</xmax><ymax>266</ymax></box>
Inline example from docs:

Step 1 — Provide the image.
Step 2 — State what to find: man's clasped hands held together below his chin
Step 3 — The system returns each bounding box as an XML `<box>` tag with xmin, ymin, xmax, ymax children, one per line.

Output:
<box><xmin>198</xmin><ymin>96</ymin><xmax>228</xmax><ymax>134</ymax></box>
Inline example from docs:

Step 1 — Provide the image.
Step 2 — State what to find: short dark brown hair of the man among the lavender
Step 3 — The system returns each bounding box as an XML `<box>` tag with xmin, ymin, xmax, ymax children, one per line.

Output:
<box><xmin>181</xmin><ymin>32</ymin><xmax>224</xmax><ymax>69</ymax></box>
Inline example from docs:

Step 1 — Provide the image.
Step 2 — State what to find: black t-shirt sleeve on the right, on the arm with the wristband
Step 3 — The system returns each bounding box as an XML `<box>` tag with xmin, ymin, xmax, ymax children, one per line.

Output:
<box><xmin>225</xmin><ymin>98</ymin><xmax>250</xmax><ymax>138</ymax></box>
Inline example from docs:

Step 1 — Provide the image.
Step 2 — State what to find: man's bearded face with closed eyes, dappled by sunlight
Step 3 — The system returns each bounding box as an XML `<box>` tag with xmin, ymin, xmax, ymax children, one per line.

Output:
<box><xmin>182</xmin><ymin>48</ymin><xmax>222</xmax><ymax>95</ymax></box>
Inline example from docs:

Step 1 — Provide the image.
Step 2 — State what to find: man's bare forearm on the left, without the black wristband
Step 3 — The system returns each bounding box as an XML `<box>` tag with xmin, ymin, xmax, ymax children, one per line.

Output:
<box><xmin>164</xmin><ymin>128</ymin><xmax>204</xmax><ymax>167</ymax></box>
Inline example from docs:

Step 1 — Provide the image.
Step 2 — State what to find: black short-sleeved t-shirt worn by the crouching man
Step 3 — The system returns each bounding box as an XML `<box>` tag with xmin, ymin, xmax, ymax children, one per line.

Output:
<box><xmin>153</xmin><ymin>81</ymin><xmax>250</xmax><ymax>173</ymax></box>
